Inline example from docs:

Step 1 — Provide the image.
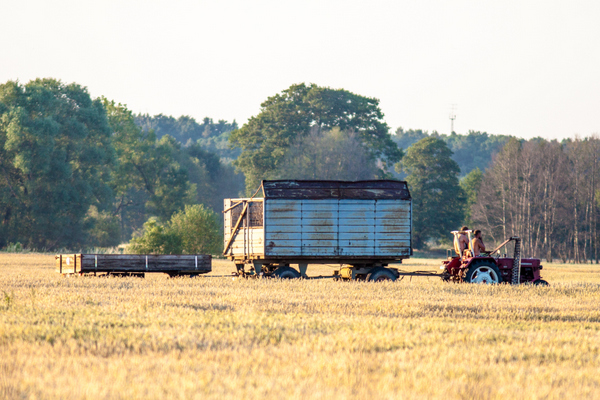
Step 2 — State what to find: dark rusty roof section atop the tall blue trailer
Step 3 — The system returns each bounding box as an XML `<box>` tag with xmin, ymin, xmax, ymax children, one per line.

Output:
<box><xmin>261</xmin><ymin>180</ymin><xmax>411</xmax><ymax>200</ymax></box>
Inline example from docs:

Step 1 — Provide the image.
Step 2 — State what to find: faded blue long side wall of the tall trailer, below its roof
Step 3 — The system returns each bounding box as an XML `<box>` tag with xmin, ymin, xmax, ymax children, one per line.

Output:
<box><xmin>264</xmin><ymin>199</ymin><xmax>411</xmax><ymax>257</ymax></box>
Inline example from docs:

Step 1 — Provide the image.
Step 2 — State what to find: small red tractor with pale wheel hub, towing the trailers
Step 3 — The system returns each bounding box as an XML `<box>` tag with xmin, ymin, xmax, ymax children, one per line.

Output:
<box><xmin>440</xmin><ymin>231</ymin><xmax>548</xmax><ymax>285</ymax></box>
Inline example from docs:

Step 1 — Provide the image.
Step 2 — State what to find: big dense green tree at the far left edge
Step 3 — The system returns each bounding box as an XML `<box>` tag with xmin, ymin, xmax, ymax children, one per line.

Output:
<box><xmin>0</xmin><ymin>79</ymin><xmax>114</xmax><ymax>249</ymax></box>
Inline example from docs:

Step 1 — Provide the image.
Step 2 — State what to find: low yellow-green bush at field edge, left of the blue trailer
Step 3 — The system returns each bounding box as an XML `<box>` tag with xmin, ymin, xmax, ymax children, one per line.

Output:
<box><xmin>130</xmin><ymin>204</ymin><xmax>222</xmax><ymax>254</ymax></box>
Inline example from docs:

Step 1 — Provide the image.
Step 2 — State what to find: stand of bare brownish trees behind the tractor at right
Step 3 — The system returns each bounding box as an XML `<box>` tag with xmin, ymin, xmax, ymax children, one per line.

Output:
<box><xmin>472</xmin><ymin>136</ymin><xmax>600</xmax><ymax>262</ymax></box>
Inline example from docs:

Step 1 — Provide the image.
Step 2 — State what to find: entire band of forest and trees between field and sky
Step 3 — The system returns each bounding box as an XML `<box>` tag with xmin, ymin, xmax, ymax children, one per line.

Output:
<box><xmin>0</xmin><ymin>79</ymin><xmax>600</xmax><ymax>262</ymax></box>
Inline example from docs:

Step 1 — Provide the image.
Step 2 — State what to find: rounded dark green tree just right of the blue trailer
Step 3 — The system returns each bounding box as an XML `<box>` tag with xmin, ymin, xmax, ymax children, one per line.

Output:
<box><xmin>396</xmin><ymin>137</ymin><xmax>465</xmax><ymax>249</ymax></box>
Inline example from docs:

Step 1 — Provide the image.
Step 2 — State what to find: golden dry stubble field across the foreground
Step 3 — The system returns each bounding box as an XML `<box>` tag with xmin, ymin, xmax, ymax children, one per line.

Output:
<box><xmin>0</xmin><ymin>254</ymin><xmax>600</xmax><ymax>399</ymax></box>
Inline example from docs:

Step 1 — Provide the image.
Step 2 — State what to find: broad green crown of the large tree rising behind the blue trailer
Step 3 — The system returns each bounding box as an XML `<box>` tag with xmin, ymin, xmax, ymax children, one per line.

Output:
<box><xmin>229</xmin><ymin>83</ymin><xmax>402</xmax><ymax>192</ymax></box>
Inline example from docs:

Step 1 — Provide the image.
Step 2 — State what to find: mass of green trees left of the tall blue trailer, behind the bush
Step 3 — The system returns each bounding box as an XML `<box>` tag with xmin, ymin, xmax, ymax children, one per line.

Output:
<box><xmin>0</xmin><ymin>79</ymin><xmax>243</xmax><ymax>249</ymax></box>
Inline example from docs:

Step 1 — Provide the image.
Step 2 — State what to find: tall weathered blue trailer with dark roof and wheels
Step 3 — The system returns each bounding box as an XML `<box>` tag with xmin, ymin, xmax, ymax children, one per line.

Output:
<box><xmin>223</xmin><ymin>180</ymin><xmax>412</xmax><ymax>281</ymax></box>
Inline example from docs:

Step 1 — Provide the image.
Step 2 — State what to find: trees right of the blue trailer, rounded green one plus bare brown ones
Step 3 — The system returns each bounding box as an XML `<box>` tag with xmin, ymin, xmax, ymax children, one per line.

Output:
<box><xmin>397</xmin><ymin>135</ymin><xmax>600</xmax><ymax>263</ymax></box>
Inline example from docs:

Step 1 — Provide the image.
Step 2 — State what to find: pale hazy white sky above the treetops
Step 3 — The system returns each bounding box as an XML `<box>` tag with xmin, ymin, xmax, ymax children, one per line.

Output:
<box><xmin>0</xmin><ymin>0</ymin><xmax>600</xmax><ymax>138</ymax></box>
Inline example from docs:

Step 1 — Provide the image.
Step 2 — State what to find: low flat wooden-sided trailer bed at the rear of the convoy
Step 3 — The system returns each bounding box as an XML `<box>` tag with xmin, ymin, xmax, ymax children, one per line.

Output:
<box><xmin>55</xmin><ymin>254</ymin><xmax>212</xmax><ymax>276</ymax></box>
